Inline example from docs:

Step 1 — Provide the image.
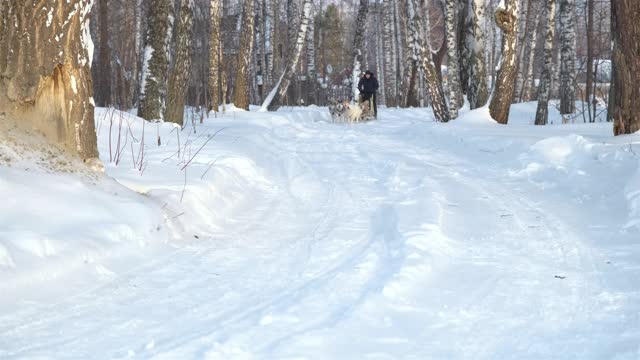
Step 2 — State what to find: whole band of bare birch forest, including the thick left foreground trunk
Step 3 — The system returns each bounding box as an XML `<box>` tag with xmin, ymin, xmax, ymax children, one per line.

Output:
<box><xmin>0</xmin><ymin>0</ymin><xmax>640</xmax><ymax>158</ymax></box>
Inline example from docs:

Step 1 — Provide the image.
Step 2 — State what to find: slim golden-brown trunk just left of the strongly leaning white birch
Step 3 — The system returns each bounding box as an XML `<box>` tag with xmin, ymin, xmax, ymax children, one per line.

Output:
<box><xmin>233</xmin><ymin>0</ymin><xmax>255</xmax><ymax>110</ymax></box>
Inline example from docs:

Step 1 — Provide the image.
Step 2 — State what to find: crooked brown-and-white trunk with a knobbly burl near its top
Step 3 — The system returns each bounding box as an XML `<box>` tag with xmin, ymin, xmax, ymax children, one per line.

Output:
<box><xmin>489</xmin><ymin>0</ymin><xmax>518</xmax><ymax>124</ymax></box>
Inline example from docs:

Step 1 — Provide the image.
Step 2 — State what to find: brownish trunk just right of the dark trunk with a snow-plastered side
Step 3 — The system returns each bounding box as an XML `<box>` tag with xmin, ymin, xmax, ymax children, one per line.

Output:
<box><xmin>164</xmin><ymin>0</ymin><xmax>194</xmax><ymax>125</ymax></box>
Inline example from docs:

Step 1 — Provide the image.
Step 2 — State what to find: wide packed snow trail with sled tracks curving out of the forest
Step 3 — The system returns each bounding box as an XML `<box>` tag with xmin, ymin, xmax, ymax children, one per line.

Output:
<box><xmin>0</xmin><ymin>105</ymin><xmax>640</xmax><ymax>359</ymax></box>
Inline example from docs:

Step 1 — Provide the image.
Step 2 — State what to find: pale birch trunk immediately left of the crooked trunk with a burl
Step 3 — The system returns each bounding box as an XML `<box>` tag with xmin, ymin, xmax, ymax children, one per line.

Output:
<box><xmin>468</xmin><ymin>0</ymin><xmax>489</xmax><ymax>109</ymax></box>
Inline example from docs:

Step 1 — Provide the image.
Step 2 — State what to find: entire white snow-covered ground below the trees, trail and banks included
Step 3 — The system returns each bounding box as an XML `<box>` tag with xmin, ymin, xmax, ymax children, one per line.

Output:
<box><xmin>0</xmin><ymin>104</ymin><xmax>640</xmax><ymax>359</ymax></box>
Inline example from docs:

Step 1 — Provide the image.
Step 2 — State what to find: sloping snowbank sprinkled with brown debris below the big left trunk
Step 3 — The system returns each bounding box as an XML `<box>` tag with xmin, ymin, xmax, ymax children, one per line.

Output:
<box><xmin>0</xmin><ymin>119</ymin><xmax>167</xmax><ymax>305</ymax></box>
